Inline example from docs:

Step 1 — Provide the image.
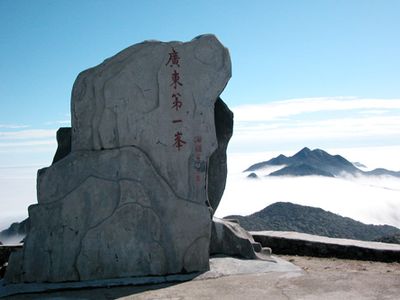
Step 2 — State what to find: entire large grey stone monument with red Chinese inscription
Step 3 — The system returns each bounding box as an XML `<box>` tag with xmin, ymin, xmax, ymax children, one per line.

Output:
<box><xmin>6</xmin><ymin>35</ymin><xmax>232</xmax><ymax>283</ymax></box>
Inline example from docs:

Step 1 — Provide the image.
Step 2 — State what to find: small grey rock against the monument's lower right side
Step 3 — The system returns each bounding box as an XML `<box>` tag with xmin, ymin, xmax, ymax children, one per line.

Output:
<box><xmin>210</xmin><ymin>217</ymin><xmax>272</xmax><ymax>260</ymax></box>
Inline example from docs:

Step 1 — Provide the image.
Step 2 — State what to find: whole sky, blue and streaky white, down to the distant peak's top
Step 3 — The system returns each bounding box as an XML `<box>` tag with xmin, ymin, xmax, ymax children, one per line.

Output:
<box><xmin>0</xmin><ymin>0</ymin><xmax>400</xmax><ymax>225</ymax></box>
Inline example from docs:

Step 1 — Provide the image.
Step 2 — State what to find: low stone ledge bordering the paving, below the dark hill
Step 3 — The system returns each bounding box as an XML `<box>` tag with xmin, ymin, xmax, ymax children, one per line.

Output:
<box><xmin>250</xmin><ymin>231</ymin><xmax>400</xmax><ymax>262</ymax></box>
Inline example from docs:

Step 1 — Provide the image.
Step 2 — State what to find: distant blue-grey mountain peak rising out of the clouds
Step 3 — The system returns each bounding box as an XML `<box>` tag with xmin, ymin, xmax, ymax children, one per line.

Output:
<box><xmin>244</xmin><ymin>147</ymin><xmax>400</xmax><ymax>177</ymax></box>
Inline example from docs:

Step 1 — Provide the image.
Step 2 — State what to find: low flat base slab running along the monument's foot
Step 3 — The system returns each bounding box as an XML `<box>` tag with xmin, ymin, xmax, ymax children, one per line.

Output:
<box><xmin>0</xmin><ymin>257</ymin><xmax>303</xmax><ymax>298</ymax></box>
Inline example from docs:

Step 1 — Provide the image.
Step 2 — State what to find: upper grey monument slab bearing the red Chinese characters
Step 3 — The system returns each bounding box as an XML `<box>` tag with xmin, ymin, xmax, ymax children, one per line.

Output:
<box><xmin>71</xmin><ymin>35</ymin><xmax>231</xmax><ymax>202</ymax></box>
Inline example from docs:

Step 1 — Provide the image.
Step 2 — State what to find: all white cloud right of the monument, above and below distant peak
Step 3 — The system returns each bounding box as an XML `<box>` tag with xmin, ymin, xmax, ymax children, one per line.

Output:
<box><xmin>216</xmin><ymin>97</ymin><xmax>400</xmax><ymax>228</ymax></box>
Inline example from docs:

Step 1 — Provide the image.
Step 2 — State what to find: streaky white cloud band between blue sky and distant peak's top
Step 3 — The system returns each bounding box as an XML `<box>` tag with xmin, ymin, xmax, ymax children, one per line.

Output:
<box><xmin>229</xmin><ymin>97</ymin><xmax>400</xmax><ymax>152</ymax></box>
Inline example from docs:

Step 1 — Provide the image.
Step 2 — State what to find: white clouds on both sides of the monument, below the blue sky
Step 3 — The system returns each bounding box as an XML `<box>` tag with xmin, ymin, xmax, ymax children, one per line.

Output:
<box><xmin>0</xmin><ymin>97</ymin><xmax>400</xmax><ymax>230</ymax></box>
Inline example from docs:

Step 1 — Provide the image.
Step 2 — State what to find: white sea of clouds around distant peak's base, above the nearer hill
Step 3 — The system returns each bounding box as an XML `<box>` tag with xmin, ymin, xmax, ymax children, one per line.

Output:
<box><xmin>216</xmin><ymin>151</ymin><xmax>400</xmax><ymax>228</ymax></box>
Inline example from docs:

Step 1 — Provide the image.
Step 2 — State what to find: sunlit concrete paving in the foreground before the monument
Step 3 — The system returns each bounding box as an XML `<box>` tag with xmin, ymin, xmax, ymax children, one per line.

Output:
<box><xmin>3</xmin><ymin>256</ymin><xmax>400</xmax><ymax>300</ymax></box>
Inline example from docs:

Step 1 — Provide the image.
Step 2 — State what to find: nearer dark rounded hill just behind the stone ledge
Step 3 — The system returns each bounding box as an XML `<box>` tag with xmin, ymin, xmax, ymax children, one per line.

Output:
<box><xmin>225</xmin><ymin>202</ymin><xmax>400</xmax><ymax>241</ymax></box>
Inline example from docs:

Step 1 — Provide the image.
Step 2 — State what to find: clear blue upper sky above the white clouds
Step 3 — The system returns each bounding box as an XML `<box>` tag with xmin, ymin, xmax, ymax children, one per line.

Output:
<box><xmin>0</xmin><ymin>0</ymin><xmax>400</xmax><ymax>126</ymax></box>
